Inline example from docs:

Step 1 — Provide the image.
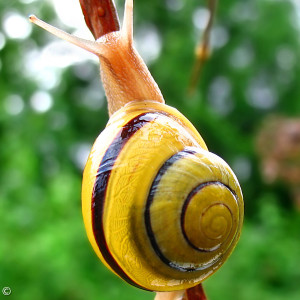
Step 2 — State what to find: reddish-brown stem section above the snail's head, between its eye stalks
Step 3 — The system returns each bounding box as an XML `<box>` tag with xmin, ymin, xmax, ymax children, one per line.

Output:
<box><xmin>79</xmin><ymin>0</ymin><xmax>120</xmax><ymax>39</ymax></box>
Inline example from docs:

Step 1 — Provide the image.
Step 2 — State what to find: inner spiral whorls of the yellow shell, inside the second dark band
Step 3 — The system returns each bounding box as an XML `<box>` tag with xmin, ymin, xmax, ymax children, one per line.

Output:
<box><xmin>145</xmin><ymin>147</ymin><xmax>240</xmax><ymax>272</ymax></box>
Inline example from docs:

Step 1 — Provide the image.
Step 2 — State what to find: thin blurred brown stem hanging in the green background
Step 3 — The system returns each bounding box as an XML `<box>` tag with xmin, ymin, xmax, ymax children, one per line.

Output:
<box><xmin>188</xmin><ymin>0</ymin><xmax>218</xmax><ymax>95</ymax></box>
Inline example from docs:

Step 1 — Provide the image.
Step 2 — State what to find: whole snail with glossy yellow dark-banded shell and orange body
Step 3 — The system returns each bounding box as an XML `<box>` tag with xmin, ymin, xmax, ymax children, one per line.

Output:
<box><xmin>30</xmin><ymin>0</ymin><xmax>243</xmax><ymax>291</ymax></box>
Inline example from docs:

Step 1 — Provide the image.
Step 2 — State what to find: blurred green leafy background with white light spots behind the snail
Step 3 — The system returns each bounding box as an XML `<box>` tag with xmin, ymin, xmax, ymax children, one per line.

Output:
<box><xmin>0</xmin><ymin>0</ymin><xmax>300</xmax><ymax>300</ymax></box>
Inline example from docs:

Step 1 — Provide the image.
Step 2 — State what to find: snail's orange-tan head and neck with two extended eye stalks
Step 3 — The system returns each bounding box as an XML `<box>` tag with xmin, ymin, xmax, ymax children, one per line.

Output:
<box><xmin>29</xmin><ymin>0</ymin><xmax>165</xmax><ymax>115</ymax></box>
